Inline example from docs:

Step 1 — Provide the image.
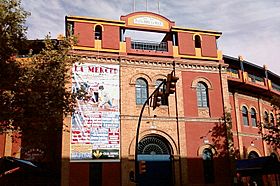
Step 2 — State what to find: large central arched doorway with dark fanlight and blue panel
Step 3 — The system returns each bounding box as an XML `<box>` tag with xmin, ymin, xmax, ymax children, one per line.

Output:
<box><xmin>138</xmin><ymin>135</ymin><xmax>173</xmax><ymax>186</ymax></box>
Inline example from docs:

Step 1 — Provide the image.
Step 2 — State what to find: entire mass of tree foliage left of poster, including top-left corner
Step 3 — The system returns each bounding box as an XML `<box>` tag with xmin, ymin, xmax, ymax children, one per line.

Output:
<box><xmin>0</xmin><ymin>0</ymin><xmax>77</xmax><ymax>141</ymax></box>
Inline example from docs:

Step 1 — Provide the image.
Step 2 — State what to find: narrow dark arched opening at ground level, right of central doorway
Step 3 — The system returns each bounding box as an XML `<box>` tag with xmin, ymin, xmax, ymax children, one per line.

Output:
<box><xmin>202</xmin><ymin>148</ymin><xmax>214</xmax><ymax>183</ymax></box>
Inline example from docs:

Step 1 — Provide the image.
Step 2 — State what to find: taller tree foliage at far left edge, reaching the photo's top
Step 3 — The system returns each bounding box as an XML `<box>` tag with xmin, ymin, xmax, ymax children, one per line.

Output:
<box><xmin>0</xmin><ymin>0</ymin><xmax>29</xmax><ymax>132</ymax></box>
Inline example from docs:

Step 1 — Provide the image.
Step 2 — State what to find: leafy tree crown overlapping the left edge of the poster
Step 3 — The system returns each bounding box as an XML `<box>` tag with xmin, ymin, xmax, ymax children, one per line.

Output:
<box><xmin>13</xmin><ymin>38</ymin><xmax>77</xmax><ymax>140</ymax></box>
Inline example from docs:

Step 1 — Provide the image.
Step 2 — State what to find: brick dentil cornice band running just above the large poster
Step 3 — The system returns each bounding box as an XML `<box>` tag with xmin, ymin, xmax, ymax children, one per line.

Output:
<box><xmin>71</xmin><ymin>50</ymin><xmax>227</xmax><ymax>73</ymax></box>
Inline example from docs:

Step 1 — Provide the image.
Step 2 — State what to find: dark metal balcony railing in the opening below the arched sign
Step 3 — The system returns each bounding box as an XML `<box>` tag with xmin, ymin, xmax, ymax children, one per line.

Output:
<box><xmin>131</xmin><ymin>40</ymin><xmax>167</xmax><ymax>52</ymax></box>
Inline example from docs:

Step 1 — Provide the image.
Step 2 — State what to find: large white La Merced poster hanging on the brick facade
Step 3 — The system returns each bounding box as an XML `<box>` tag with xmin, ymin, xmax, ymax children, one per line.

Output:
<box><xmin>70</xmin><ymin>63</ymin><xmax>120</xmax><ymax>161</ymax></box>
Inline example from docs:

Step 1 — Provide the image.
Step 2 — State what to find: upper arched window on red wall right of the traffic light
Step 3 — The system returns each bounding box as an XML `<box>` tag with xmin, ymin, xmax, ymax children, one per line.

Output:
<box><xmin>196</xmin><ymin>82</ymin><xmax>209</xmax><ymax>107</ymax></box>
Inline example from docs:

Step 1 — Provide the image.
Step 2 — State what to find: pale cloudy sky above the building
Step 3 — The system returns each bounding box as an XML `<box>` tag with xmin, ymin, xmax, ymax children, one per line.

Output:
<box><xmin>22</xmin><ymin>0</ymin><xmax>280</xmax><ymax>75</ymax></box>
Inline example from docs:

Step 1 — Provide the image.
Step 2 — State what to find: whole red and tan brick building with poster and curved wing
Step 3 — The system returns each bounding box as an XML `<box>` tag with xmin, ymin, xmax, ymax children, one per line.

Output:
<box><xmin>0</xmin><ymin>12</ymin><xmax>280</xmax><ymax>186</ymax></box>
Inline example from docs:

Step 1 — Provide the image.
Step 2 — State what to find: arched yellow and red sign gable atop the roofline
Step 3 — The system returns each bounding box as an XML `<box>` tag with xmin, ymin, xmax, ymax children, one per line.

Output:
<box><xmin>121</xmin><ymin>12</ymin><xmax>175</xmax><ymax>32</ymax></box>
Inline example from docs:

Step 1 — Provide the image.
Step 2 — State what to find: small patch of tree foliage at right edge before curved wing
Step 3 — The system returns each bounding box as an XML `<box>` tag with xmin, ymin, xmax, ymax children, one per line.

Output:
<box><xmin>259</xmin><ymin>96</ymin><xmax>280</xmax><ymax>149</ymax></box>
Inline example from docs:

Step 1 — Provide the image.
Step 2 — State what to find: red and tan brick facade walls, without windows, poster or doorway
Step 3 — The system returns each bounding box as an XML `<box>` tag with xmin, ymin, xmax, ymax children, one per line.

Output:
<box><xmin>0</xmin><ymin>12</ymin><xmax>280</xmax><ymax>186</ymax></box>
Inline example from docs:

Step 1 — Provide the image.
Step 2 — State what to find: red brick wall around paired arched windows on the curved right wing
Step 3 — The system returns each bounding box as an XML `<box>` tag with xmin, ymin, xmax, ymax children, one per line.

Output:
<box><xmin>230</xmin><ymin>92</ymin><xmax>277</xmax><ymax>159</ymax></box>
